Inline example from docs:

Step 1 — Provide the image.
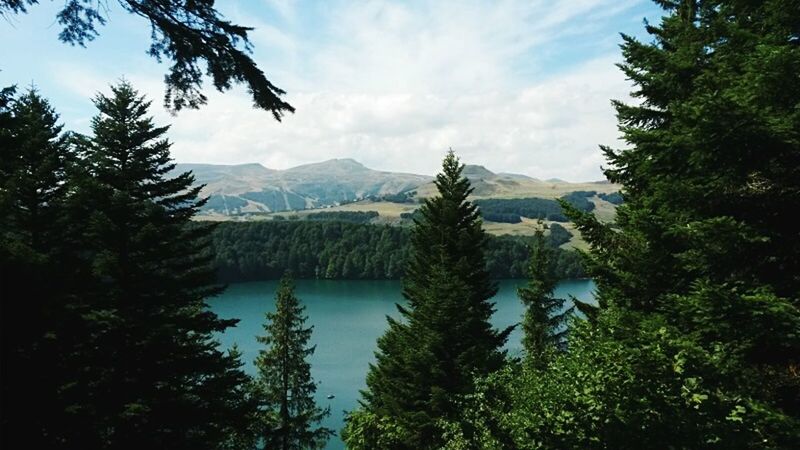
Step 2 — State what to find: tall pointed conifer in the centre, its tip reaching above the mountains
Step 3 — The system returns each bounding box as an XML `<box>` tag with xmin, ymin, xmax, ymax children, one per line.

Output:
<box><xmin>344</xmin><ymin>151</ymin><xmax>510</xmax><ymax>449</ymax></box>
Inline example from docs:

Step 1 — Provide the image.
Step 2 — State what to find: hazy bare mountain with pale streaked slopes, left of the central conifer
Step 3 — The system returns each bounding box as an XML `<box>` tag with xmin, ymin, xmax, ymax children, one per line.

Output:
<box><xmin>175</xmin><ymin>159</ymin><xmax>433</xmax><ymax>215</ymax></box>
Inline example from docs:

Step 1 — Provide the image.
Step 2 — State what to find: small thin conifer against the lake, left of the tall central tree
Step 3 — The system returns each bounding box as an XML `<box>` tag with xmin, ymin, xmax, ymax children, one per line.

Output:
<box><xmin>255</xmin><ymin>275</ymin><xmax>333</xmax><ymax>450</ymax></box>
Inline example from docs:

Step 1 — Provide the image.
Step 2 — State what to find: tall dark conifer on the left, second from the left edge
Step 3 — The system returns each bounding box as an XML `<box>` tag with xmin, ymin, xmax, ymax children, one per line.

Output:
<box><xmin>67</xmin><ymin>82</ymin><xmax>250</xmax><ymax>449</ymax></box>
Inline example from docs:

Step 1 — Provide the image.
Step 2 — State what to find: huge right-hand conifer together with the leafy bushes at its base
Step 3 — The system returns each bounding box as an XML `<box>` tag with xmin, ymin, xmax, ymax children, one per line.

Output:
<box><xmin>442</xmin><ymin>0</ymin><xmax>800</xmax><ymax>449</ymax></box>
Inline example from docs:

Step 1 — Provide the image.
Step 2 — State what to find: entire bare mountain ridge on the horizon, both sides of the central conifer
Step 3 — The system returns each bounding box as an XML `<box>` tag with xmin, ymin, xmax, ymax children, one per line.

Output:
<box><xmin>173</xmin><ymin>158</ymin><xmax>617</xmax><ymax>215</ymax></box>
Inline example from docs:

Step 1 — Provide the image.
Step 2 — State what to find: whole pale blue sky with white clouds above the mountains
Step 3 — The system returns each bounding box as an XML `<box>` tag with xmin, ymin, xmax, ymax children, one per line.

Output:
<box><xmin>0</xmin><ymin>0</ymin><xmax>661</xmax><ymax>181</ymax></box>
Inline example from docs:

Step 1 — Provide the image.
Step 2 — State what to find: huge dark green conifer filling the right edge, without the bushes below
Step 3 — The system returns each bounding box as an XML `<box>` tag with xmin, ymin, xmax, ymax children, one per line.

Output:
<box><xmin>570</xmin><ymin>0</ymin><xmax>800</xmax><ymax>442</ymax></box>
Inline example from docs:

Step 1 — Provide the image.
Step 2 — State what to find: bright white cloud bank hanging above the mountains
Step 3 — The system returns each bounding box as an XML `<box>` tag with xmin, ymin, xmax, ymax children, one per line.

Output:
<box><xmin>50</xmin><ymin>0</ymin><xmax>636</xmax><ymax>181</ymax></box>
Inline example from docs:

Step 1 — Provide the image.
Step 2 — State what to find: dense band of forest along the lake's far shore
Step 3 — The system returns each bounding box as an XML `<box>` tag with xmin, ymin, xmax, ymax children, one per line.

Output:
<box><xmin>206</xmin><ymin>221</ymin><xmax>584</xmax><ymax>283</ymax></box>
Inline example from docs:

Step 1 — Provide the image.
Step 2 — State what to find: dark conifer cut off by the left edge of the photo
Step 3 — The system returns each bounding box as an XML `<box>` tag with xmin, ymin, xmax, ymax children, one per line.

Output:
<box><xmin>0</xmin><ymin>88</ymin><xmax>79</xmax><ymax>447</ymax></box>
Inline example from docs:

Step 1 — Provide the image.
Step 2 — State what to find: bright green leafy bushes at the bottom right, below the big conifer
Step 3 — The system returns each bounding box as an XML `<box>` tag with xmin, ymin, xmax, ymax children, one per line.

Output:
<box><xmin>443</xmin><ymin>307</ymin><xmax>800</xmax><ymax>450</ymax></box>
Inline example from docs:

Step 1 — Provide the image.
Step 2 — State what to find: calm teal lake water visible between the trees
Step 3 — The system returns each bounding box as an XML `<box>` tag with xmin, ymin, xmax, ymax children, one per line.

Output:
<box><xmin>209</xmin><ymin>280</ymin><xmax>594</xmax><ymax>449</ymax></box>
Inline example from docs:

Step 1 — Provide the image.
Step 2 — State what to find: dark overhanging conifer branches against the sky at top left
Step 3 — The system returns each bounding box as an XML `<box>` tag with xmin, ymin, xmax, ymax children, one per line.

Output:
<box><xmin>0</xmin><ymin>0</ymin><xmax>294</xmax><ymax>120</ymax></box>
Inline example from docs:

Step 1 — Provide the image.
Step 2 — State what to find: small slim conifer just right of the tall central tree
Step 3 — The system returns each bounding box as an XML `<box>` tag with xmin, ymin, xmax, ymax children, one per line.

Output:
<box><xmin>517</xmin><ymin>230</ymin><xmax>573</xmax><ymax>367</ymax></box>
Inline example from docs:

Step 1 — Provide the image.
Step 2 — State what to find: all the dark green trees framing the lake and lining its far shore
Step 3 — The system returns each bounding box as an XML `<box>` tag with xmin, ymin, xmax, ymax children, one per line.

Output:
<box><xmin>0</xmin><ymin>0</ymin><xmax>800</xmax><ymax>450</ymax></box>
